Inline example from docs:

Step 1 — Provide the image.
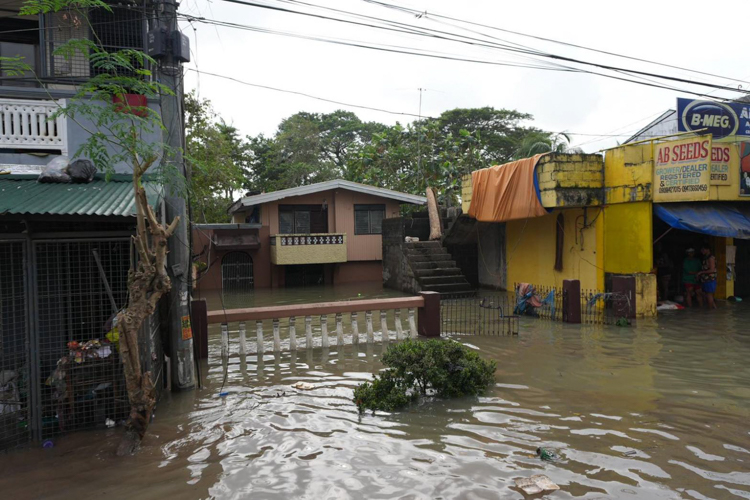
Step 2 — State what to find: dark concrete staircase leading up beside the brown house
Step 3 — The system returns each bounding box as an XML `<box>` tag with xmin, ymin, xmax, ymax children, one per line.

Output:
<box><xmin>406</xmin><ymin>241</ymin><xmax>472</xmax><ymax>294</ymax></box>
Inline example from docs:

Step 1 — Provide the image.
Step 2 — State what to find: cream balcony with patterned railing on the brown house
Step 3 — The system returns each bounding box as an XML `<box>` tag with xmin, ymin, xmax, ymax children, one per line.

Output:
<box><xmin>271</xmin><ymin>233</ymin><xmax>346</xmax><ymax>266</ymax></box>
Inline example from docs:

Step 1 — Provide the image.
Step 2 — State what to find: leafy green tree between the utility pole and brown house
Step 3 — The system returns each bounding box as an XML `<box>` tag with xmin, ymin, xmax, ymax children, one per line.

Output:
<box><xmin>185</xmin><ymin>92</ymin><xmax>251</xmax><ymax>222</ymax></box>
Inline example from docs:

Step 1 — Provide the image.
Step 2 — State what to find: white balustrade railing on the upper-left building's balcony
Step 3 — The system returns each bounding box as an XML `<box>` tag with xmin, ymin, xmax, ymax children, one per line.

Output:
<box><xmin>0</xmin><ymin>99</ymin><xmax>68</xmax><ymax>154</ymax></box>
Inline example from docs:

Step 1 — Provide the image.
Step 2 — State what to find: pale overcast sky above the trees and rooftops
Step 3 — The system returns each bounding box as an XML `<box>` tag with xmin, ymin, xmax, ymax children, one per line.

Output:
<box><xmin>180</xmin><ymin>0</ymin><xmax>750</xmax><ymax>151</ymax></box>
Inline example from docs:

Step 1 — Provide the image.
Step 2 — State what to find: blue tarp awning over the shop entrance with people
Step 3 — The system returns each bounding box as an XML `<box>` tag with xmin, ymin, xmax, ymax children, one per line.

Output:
<box><xmin>654</xmin><ymin>202</ymin><xmax>750</xmax><ymax>240</ymax></box>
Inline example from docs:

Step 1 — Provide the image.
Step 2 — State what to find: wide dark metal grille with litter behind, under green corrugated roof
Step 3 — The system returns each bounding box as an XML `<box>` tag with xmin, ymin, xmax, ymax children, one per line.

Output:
<box><xmin>34</xmin><ymin>239</ymin><xmax>131</xmax><ymax>438</ymax></box>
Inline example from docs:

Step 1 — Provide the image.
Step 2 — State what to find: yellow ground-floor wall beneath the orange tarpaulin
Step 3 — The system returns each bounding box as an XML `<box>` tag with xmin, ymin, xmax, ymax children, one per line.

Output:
<box><xmin>505</xmin><ymin>208</ymin><xmax>604</xmax><ymax>290</ymax></box>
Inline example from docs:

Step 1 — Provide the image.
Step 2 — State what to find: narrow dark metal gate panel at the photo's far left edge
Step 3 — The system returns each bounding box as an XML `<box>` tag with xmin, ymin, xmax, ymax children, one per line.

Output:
<box><xmin>0</xmin><ymin>241</ymin><xmax>31</xmax><ymax>450</ymax></box>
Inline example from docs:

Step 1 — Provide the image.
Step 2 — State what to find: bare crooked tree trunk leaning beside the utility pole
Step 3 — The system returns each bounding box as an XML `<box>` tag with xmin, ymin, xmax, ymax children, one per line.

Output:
<box><xmin>117</xmin><ymin>160</ymin><xmax>179</xmax><ymax>456</ymax></box>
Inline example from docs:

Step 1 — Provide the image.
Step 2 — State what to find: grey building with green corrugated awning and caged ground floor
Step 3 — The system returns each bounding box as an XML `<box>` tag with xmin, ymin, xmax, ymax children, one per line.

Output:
<box><xmin>0</xmin><ymin>0</ymin><xmax>172</xmax><ymax>450</ymax></box>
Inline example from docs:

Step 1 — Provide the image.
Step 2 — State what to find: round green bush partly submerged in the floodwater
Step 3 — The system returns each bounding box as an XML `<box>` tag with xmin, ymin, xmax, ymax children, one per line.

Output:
<box><xmin>354</xmin><ymin>339</ymin><xmax>497</xmax><ymax>413</ymax></box>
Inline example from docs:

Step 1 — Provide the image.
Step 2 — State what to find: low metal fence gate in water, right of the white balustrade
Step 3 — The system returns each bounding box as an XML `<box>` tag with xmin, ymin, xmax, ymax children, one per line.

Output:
<box><xmin>440</xmin><ymin>292</ymin><xmax>518</xmax><ymax>335</ymax></box>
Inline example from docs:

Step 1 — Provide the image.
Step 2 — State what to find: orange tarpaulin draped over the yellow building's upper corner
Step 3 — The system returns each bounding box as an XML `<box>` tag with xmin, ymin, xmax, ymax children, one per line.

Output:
<box><xmin>469</xmin><ymin>154</ymin><xmax>547</xmax><ymax>222</ymax></box>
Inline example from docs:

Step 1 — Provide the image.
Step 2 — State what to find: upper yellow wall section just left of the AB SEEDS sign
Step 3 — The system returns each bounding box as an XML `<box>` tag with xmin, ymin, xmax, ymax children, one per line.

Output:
<box><xmin>604</xmin><ymin>143</ymin><xmax>654</xmax><ymax>204</ymax></box>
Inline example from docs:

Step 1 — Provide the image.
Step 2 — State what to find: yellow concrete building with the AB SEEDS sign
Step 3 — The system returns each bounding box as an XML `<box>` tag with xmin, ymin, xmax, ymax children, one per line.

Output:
<box><xmin>462</xmin><ymin>99</ymin><xmax>750</xmax><ymax>316</ymax></box>
